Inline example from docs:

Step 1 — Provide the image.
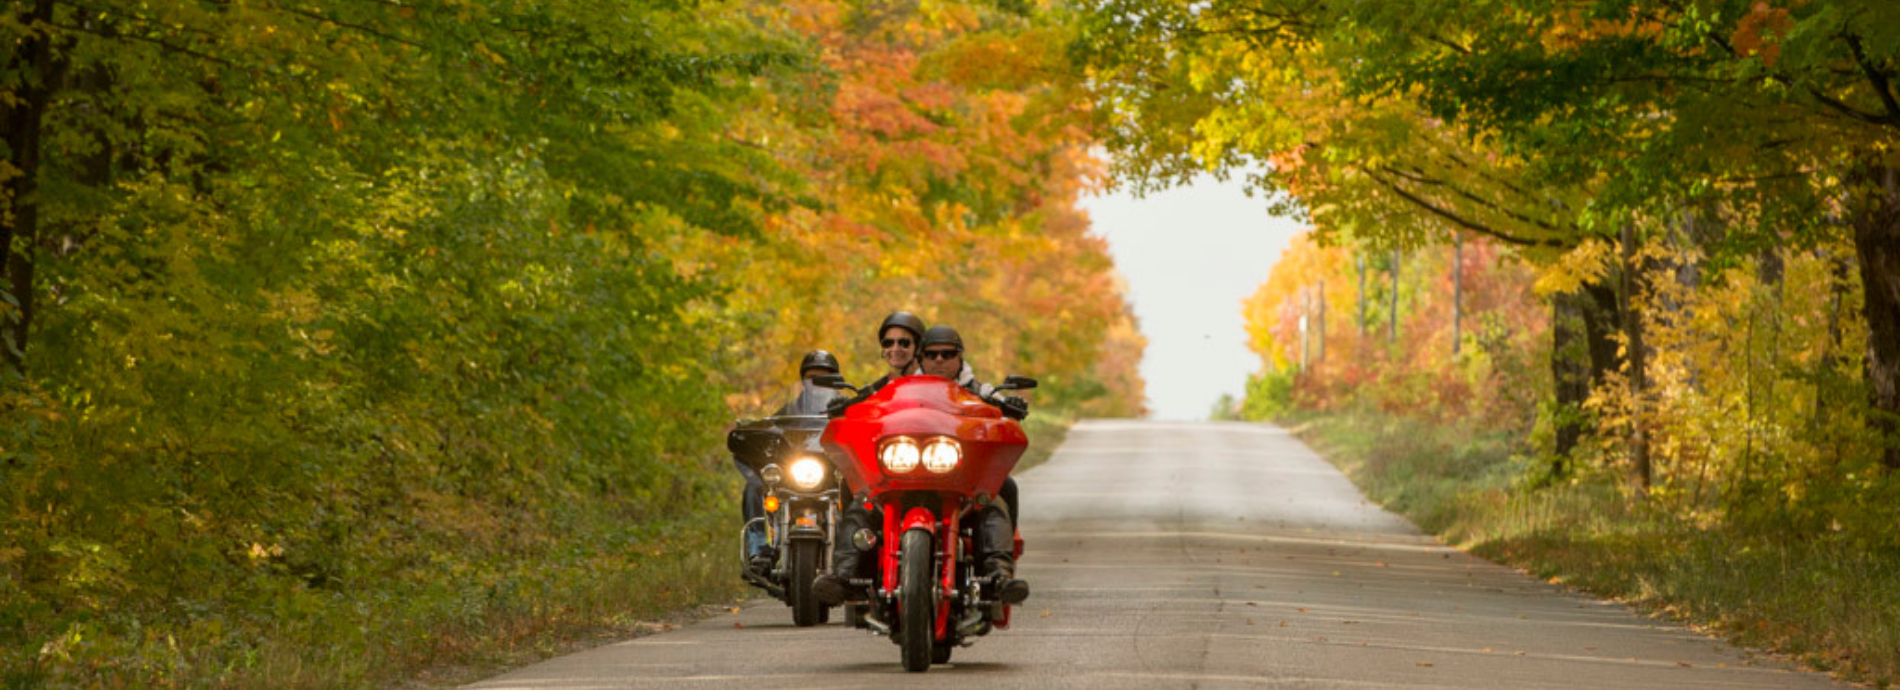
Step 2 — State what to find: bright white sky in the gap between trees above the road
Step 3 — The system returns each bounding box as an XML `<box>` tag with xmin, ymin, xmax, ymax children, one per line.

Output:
<box><xmin>1081</xmin><ymin>177</ymin><xmax>1300</xmax><ymax>420</ymax></box>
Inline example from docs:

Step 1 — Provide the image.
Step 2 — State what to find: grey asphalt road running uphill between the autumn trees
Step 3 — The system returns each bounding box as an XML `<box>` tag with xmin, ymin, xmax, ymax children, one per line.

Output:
<box><xmin>473</xmin><ymin>422</ymin><xmax>1839</xmax><ymax>690</ymax></box>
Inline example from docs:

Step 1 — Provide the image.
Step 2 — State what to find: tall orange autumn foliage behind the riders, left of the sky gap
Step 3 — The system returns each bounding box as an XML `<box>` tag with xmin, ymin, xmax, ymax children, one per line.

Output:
<box><xmin>686</xmin><ymin>0</ymin><xmax>1144</xmax><ymax>416</ymax></box>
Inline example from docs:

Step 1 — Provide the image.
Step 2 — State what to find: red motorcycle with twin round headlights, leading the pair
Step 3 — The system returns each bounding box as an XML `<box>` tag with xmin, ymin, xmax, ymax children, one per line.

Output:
<box><xmin>817</xmin><ymin>376</ymin><xmax>1036</xmax><ymax>671</ymax></box>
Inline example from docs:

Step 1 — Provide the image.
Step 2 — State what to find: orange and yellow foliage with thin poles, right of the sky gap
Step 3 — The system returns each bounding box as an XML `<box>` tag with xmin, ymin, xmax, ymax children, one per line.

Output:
<box><xmin>1243</xmin><ymin>232</ymin><xmax>1549</xmax><ymax>426</ymax></box>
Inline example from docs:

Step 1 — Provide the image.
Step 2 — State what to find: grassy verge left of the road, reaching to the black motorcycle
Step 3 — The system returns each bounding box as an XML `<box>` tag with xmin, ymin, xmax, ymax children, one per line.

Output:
<box><xmin>14</xmin><ymin>511</ymin><xmax>741</xmax><ymax>688</ymax></box>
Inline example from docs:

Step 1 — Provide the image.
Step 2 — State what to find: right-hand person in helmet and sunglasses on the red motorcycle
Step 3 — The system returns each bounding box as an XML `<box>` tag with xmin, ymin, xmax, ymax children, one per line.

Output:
<box><xmin>922</xmin><ymin>325</ymin><xmax>1030</xmax><ymax>604</ymax></box>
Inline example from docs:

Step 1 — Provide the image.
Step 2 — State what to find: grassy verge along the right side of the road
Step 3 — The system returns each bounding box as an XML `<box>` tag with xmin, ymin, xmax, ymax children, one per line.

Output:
<box><xmin>1286</xmin><ymin>412</ymin><xmax>1900</xmax><ymax>688</ymax></box>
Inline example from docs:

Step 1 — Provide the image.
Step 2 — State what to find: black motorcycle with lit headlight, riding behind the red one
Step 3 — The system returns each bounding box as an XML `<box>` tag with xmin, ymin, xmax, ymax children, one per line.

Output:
<box><xmin>726</xmin><ymin>386</ymin><xmax>846</xmax><ymax>627</ymax></box>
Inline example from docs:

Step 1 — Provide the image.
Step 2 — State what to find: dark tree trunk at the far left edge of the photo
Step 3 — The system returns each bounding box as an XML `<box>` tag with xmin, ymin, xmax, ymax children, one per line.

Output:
<box><xmin>0</xmin><ymin>0</ymin><xmax>61</xmax><ymax>374</ymax></box>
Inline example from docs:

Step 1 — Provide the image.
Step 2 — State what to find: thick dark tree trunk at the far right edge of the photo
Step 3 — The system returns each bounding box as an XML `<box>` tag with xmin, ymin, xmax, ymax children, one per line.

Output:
<box><xmin>1849</xmin><ymin>165</ymin><xmax>1900</xmax><ymax>470</ymax></box>
